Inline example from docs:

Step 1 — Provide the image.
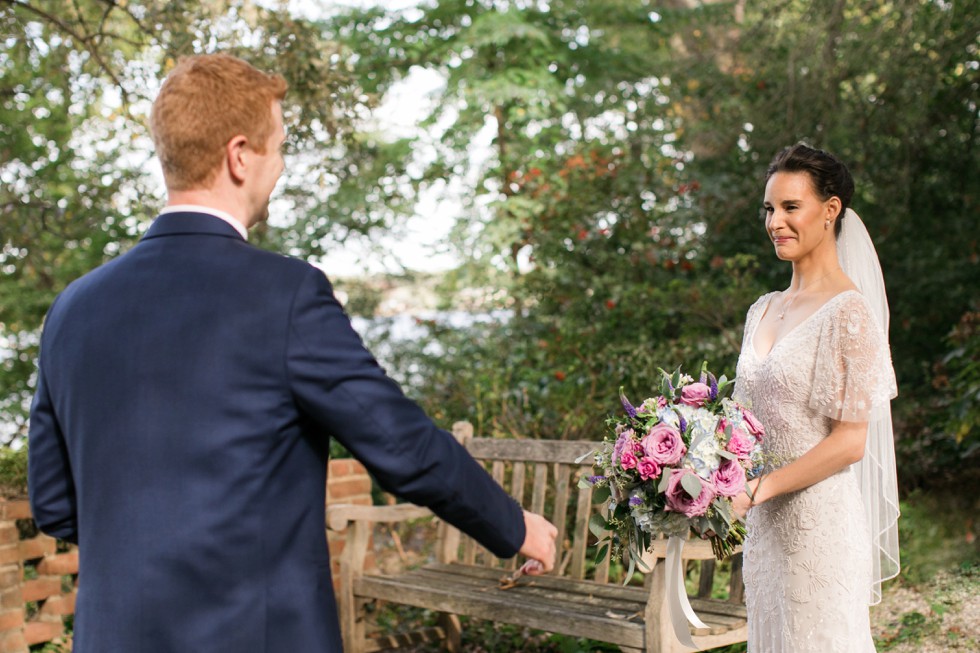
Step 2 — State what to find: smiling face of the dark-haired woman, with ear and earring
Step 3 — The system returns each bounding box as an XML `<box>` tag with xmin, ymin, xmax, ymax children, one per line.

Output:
<box><xmin>763</xmin><ymin>172</ymin><xmax>840</xmax><ymax>261</ymax></box>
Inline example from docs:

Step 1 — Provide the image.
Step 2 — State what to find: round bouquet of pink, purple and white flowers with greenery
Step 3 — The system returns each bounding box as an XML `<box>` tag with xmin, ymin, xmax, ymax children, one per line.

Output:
<box><xmin>581</xmin><ymin>364</ymin><xmax>764</xmax><ymax>576</ymax></box>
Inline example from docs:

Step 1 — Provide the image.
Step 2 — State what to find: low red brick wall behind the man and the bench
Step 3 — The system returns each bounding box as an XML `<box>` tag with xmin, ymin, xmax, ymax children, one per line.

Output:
<box><xmin>0</xmin><ymin>459</ymin><xmax>374</xmax><ymax>653</ymax></box>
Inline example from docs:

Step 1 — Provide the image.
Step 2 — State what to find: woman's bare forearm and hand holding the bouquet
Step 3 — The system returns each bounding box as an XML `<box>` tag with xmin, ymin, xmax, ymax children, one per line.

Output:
<box><xmin>734</xmin><ymin>421</ymin><xmax>868</xmax><ymax>517</ymax></box>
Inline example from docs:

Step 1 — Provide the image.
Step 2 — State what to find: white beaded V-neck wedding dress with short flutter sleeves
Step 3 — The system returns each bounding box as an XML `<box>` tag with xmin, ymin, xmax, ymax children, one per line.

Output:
<box><xmin>735</xmin><ymin>290</ymin><xmax>896</xmax><ymax>653</ymax></box>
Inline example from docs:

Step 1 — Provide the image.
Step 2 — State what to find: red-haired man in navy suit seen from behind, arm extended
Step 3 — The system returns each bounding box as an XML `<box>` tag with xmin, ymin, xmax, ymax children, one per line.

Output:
<box><xmin>29</xmin><ymin>55</ymin><xmax>555</xmax><ymax>653</ymax></box>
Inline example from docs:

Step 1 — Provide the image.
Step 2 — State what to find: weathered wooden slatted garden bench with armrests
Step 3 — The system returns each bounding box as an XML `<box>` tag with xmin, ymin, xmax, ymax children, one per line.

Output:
<box><xmin>327</xmin><ymin>422</ymin><xmax>747</xmax><ymax>653</ymax></box>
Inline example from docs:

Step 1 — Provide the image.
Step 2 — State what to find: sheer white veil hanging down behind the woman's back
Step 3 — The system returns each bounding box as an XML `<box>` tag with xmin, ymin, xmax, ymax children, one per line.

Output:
<box><xmin>837</xmin><ymin>209</ymin><xmax>899</xmax><ymax>605</ymax></box>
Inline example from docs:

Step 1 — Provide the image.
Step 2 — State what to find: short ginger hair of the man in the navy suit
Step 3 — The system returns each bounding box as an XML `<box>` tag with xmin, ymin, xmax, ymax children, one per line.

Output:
<box><xmin>150</xmin><ymin>54</ymin><xmax>287</xmax><ymax>190</ymax></box>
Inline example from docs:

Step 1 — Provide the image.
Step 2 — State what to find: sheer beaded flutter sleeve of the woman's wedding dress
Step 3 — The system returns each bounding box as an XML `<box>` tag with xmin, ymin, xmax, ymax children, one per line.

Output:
<box><xmin>810</xmin><ymin>293</ymin><xmax>898</xmax><ymax>422</ymax></box>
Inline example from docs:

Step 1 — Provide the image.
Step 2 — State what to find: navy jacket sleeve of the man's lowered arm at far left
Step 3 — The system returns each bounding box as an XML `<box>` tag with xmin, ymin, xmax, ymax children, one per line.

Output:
<box><xmin>27</xmin><ymin>307</ymin><xmax>78</xmax><ymax>543</ymax></box>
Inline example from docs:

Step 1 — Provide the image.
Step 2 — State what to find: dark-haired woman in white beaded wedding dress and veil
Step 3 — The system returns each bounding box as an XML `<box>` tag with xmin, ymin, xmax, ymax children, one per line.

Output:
<box><xmin>735</xmin><ymin>144</ymin><xmax>899</xmax><ymax>653</ymax></box>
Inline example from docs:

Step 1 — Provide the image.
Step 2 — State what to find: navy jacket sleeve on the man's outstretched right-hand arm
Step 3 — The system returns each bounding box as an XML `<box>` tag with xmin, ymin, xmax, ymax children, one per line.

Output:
<box><xmin>286</xmin><ymin>268</ymin><xmax>525</xmax><ymax>557</ymax></box>
